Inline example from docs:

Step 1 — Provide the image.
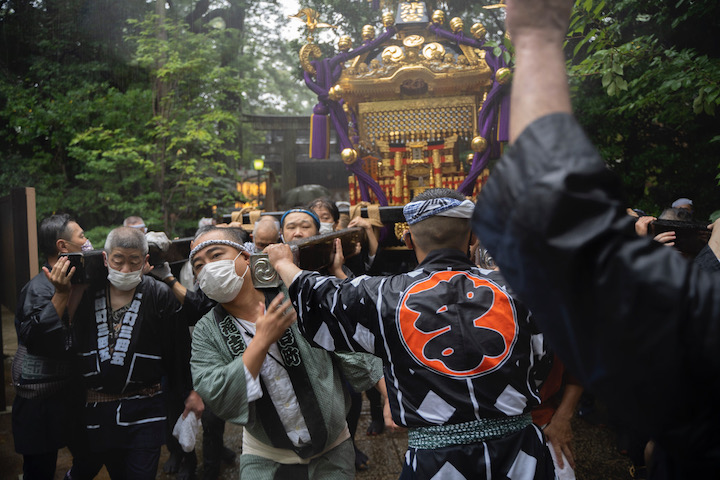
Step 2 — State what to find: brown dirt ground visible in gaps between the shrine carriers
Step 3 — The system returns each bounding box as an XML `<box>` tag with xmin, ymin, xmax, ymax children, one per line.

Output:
<box><xmin>0</xmin><ymin>307</ymin><xmax>632</xmax><ymax>480</ymax></box>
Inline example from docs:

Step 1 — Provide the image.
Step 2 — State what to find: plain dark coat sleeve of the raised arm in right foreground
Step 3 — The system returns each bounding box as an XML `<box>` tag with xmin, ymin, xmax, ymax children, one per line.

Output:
<box><xmin>474</xmin><ymin>114</ymin><xmax>720</xmax><ymax>479</ymax></box>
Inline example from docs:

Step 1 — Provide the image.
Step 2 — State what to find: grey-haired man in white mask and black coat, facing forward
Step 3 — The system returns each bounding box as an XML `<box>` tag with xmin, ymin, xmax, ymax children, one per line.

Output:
<box><xmin>72</xmin><ymin>227</ymin><xmax>203</xmax><ymax>479</ymax></box>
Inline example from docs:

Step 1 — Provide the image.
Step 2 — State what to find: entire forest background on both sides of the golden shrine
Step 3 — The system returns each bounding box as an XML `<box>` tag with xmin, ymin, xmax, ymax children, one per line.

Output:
<box><xmin>0</xmin><ymin>0</ymin><xmax>720</xmax><ymax>243</ymax></box>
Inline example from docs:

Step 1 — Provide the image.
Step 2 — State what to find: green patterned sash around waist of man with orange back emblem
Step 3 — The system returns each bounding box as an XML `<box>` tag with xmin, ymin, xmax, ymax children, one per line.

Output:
<box><xmin>408</xmin><ymin>413</ymin><xmax>532</xmax><ymax>449</ymax></box>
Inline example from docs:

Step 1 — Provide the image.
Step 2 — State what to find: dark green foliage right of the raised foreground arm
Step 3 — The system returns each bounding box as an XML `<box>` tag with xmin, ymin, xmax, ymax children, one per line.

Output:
<box><xmin>566</xmin><ymin>0</ymin><xmax>720</xmax><ymax>216</ymax></box>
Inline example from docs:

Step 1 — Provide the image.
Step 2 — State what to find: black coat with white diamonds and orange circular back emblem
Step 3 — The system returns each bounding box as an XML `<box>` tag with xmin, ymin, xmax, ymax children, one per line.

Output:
<box><xmin>290</xmin><ymin>249</ymin><xmax>546</xmax><ymax>427</ymax></box>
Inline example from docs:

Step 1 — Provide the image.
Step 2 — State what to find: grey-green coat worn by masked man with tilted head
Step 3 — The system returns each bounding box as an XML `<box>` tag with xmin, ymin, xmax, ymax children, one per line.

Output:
<box><xmin>190</xmin><ymin>304</ymin><xmax>383</xmax><ymax>458</ymax></box>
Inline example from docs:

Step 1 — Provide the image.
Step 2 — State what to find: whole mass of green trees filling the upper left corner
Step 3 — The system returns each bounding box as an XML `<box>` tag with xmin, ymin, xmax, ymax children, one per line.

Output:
<box><xmin>0</xmin><ymin>0</ymin><xmax>254</xmax><ymax>234</ymax></box>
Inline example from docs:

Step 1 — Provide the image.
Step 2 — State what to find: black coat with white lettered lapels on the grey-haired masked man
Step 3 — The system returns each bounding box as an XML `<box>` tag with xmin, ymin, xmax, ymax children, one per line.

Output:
<box><xmin>73</xmin><ymin>276</ymin><xmax>192</xmax><ymax>450</ymax></box>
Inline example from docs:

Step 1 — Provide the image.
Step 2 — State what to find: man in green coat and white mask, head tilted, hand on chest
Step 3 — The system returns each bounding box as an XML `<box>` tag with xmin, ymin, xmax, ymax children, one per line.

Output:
<box><xmin>190</xmin><ymin>228</ymin><xmax>382</xmax><ymax>480</ymax></box>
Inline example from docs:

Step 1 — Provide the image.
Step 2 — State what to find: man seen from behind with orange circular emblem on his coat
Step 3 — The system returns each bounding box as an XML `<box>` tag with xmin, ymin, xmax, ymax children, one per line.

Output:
<box><xmin>267</xmin><ymin>189</ymin><xmax>554</xmax><ymax>480</ymax></box>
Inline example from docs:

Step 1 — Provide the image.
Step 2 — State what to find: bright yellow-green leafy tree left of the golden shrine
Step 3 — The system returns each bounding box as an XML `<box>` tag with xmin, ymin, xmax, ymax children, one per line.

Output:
<box><xmin>69</xmin><ymin>15</ymin><xmax>248</xmax><ymax>233</ymax></box>
